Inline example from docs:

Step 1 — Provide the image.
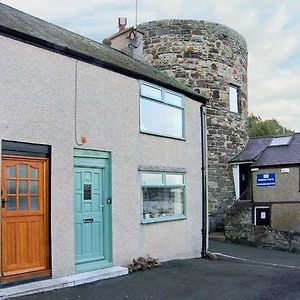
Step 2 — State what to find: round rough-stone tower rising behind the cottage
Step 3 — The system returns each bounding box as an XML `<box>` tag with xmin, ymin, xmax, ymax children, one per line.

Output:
<box><xmin>139</xmin><ymin>20</ymin><xmax>248</xmax><ymax>229</ymax></box>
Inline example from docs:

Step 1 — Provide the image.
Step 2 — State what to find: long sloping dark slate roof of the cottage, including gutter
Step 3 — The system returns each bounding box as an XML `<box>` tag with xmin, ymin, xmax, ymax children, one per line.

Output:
<box><xmin>0</xmin><ymin>3</ymin><xmax>208</xmax><ymax>103</ymax></box>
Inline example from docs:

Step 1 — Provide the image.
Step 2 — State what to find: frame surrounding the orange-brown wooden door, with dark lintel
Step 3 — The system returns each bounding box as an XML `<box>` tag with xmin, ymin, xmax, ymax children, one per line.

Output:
<box><xmin>0</xmin><ymin>154</ymin><xmax>51</xmax><ymax>283</ymax></box>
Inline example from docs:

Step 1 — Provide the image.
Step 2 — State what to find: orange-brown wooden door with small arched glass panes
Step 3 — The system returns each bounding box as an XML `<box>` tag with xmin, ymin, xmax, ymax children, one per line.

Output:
<box><xmin>1</xmin><ymin>156</ymin><xmax>49</xmax><ymax>278</ymax></box>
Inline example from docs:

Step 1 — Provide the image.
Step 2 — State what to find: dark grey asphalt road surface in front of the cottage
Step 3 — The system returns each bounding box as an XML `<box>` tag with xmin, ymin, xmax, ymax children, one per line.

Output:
<box><xmin>18</xmin><ymin>241</ymin><xmax>300</xmax><ymax>300</ymax></box>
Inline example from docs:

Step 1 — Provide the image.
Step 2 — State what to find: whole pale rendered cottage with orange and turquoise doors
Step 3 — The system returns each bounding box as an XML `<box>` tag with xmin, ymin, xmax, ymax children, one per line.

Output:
<box><xmin>0</xmin><ymin>4</ymin><xmax>207</xmax><ymax>290</ymax></box>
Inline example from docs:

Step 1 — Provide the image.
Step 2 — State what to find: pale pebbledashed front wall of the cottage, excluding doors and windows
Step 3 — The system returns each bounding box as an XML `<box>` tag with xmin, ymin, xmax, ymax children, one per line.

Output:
<box><xmin>0</xmin><ymin>36</ymin><xmax>202</xmax><ymax>277</ymax></box>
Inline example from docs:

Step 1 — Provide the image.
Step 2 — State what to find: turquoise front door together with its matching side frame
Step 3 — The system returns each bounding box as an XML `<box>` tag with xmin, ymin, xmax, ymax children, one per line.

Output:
<box><xmin>74</xmin><ymin>154</ymin><xmax>111</xmax><ymax>272</ymax></box>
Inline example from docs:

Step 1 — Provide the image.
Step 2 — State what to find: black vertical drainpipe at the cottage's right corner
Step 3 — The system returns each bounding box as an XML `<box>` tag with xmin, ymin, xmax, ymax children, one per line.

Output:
<box><xmin>200</xmin><ymin>104</ymin><xmax>208</xmax><ymax>258</ymax></box>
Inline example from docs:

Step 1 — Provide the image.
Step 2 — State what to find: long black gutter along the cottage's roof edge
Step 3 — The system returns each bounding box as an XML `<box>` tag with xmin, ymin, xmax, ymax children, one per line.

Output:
<box><xmin>0</xmin><ymin>25</ymin><xmax>208</xmax><ymax>104</ymax></box>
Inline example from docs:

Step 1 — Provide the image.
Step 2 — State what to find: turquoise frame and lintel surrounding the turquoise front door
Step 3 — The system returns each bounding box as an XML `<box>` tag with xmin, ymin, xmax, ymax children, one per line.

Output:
<box><xmin>73</xmin><ymin>148</ymin><xmax>113</xmax><ymax>273</ymax></box>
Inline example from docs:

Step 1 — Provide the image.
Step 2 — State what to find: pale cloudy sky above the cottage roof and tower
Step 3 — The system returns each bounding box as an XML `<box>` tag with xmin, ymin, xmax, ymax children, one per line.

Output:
<box><xmin>2</xmin><ymin>0</ymin><xmax>300</xmax><ymax>132</ymax></box>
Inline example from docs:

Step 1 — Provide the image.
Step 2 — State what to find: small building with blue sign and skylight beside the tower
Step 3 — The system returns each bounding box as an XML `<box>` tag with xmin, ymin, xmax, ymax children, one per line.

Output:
<box><xmin>230</xmin><ymin>133</ymin><xmax>300</xmax><ymax>232</ymax></box>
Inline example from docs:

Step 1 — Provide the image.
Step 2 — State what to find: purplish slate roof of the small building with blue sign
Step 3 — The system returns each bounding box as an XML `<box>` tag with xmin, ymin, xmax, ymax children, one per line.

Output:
<box><xmin>230</xmin><ymin>133</ymin><xmax>300</xmax><ymax>167</ymax></box>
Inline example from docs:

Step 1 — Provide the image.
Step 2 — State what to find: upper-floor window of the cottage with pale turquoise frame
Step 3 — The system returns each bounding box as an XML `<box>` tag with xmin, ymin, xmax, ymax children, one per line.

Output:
<box><xmin>140</xmin><ymin>82</ymin><xmax>184</xmax><ymax>139</ymax></box>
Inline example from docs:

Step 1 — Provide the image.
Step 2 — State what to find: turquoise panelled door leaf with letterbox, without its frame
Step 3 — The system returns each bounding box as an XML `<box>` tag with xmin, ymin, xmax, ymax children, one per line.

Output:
<box><xmin>74</xmin><ymin>167</ymin><xmax>105</xmax><ymax>265</ymax></box>
